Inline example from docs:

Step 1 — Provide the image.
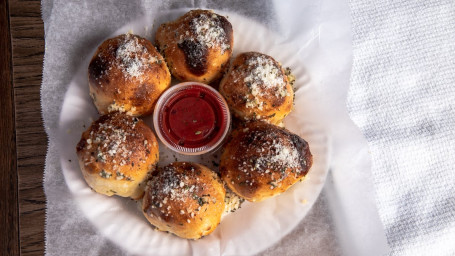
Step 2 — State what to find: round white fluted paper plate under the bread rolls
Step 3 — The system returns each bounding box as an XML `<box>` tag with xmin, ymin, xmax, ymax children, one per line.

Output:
<box><xmin>58</xmin><ymin>11</ymin><xmax>330</xmax><ymax>255</ymax></box>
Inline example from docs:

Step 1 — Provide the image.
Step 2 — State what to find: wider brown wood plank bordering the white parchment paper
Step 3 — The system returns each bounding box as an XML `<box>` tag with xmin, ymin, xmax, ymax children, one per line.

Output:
<box><xmin>9</xmin><ymin>0</ymin><xmax>47</xmax><ymax>255</ymax></box>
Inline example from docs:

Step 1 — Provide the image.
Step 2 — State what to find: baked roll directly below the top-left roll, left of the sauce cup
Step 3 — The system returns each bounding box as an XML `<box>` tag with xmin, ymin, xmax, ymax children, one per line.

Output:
<box><xmin>76</xmin><ymin>112</ymin><xmax>159</xmax><ymax>199</ymax></box>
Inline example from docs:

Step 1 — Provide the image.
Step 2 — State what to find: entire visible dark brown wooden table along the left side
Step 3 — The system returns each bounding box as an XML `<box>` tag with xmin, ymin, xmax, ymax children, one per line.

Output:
<box><xmin>0</xmin><ymin>0</ymin><xmax>47</xmax><ymax>255</ymax></box>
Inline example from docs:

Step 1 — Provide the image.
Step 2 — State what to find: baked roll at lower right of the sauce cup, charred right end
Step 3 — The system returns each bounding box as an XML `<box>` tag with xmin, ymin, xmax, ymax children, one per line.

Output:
<box><xmin>220</xmin><ymin>122</ymin><xmax>313</xmax><ymax>202</ymax></box>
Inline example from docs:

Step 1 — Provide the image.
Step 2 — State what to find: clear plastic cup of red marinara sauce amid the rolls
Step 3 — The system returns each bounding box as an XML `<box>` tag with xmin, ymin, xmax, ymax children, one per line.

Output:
<box><xmin>153</xmin><ymin>82</ymin><xmax>231</xmax><ymax>155</ymax></box>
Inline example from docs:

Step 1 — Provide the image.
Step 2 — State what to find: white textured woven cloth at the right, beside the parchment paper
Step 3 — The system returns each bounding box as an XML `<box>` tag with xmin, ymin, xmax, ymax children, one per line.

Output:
<box><xmin>348</xmin><ymin>0</ymin><xmax>455</xmax><ymax>255</ymax></box>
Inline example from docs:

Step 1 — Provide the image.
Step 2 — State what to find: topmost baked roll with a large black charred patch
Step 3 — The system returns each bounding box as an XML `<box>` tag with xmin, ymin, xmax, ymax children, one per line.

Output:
<box><xmin>155</xmin><ymin>10</ymin><xmax>234</xmax><ymax>84</ymax></box>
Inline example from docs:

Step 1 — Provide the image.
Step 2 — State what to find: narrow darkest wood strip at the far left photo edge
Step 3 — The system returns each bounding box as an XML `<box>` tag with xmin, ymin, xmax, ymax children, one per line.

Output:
<box><xmin>0</xmin><ymin>1</ymin><xmax>19</xmax><ymax>255</ymax></box>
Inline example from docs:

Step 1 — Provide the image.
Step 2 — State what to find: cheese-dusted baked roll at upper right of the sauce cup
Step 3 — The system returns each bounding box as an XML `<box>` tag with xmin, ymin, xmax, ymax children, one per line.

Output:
<box><xmin>219</xmin><ymin>52</ymin><xmax>294</xmax><ymax>124</ymax></box>
